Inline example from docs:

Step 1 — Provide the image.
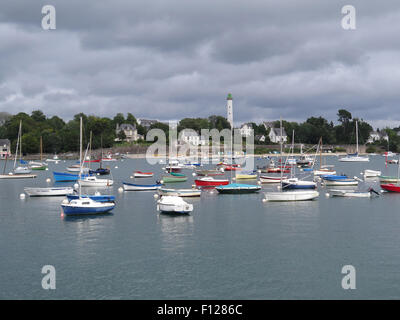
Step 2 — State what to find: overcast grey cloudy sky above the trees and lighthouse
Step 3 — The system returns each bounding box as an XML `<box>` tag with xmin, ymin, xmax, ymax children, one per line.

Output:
<box><xmin>0</xmin><ymin>0</ymin><xmax>400</xmax><ymax>127</ymax></box>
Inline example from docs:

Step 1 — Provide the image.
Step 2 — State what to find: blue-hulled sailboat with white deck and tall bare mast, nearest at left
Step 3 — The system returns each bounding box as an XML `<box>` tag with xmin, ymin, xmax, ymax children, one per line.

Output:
<box><xmin>61</xmin><ymin>117</ymin><xmax>115</xmax><ymax>215</ymax></box>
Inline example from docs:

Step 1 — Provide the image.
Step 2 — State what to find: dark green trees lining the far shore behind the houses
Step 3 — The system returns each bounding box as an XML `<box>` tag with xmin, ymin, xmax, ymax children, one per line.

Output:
<box><xmin>0</xmin><ymin>109</ymin><xmax>400</xmax><ymax>153</ymax></box>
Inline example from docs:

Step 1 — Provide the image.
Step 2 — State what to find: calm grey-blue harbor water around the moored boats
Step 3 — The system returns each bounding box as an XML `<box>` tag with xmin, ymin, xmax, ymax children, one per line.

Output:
<box><xmin>0</xmin><ymin>156</ymin><xmax>400</xmax><ymax>299</ymax></box>
